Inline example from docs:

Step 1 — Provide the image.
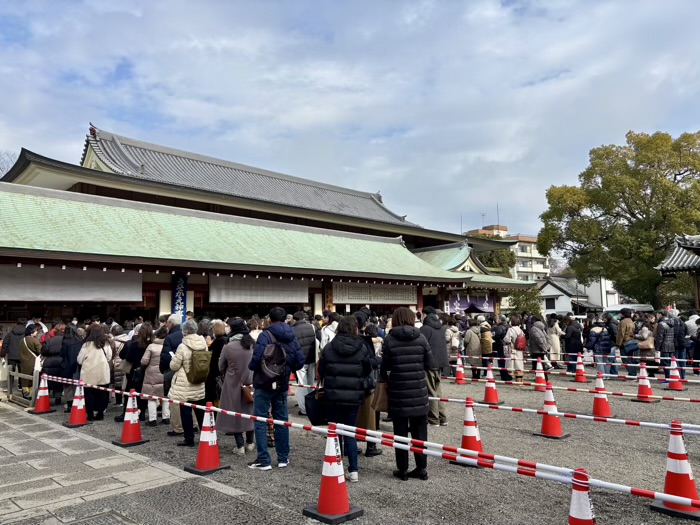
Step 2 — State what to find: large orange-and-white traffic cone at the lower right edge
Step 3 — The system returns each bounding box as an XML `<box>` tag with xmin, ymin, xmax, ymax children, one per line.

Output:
<box><xmin>651</xmin><ymin>421</ymin><xmax>700</xmax><ymax>520</ymax></box>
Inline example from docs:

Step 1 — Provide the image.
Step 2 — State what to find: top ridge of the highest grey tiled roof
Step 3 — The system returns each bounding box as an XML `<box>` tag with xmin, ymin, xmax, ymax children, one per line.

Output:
<box><xmin>88</xmin><ymin>124</ymin><xmax>386</xmax><ymax>202</ymax></box>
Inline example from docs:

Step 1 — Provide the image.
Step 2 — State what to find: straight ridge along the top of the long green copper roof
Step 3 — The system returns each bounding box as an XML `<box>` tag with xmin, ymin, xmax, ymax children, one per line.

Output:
<box><xmin>0</xmin><ymin>181</ymin><xmax>403</xmax><ymax>244</ymax></box>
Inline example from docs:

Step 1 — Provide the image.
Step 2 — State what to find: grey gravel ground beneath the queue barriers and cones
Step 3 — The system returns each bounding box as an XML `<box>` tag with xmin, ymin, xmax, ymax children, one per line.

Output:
<box><xmin>21</xmin><ymin>368</ymin><xmax>700</xmax><ymax>525</ymax></box>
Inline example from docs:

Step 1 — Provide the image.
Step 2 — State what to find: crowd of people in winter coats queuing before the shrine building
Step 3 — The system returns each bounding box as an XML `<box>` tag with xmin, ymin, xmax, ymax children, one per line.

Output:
<box><xmin>2</xmin><ymin>307</ymin><xmax>700</xmax><ymax>482</ymax></box>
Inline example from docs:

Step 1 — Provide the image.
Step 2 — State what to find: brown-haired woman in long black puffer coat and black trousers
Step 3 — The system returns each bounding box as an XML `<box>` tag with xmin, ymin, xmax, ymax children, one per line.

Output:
<box><xmin>381</xmin><ymin>307</ymin><xmax>433</xmax><ymax>481</ymax></box>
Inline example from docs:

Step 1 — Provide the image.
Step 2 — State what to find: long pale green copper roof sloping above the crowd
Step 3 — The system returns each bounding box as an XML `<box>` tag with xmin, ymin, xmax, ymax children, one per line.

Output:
<box><xmin>0</xmin><ymin>183</ymin><xmax>484</xmax><ymax>283</ymax></box>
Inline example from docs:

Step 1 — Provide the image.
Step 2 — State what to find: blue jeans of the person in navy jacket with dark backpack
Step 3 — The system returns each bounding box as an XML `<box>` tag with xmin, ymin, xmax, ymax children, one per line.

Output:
<box><xmin>253</xmin><ymin>388</ymin><xmax>289</xmax><ymax>465</ymax></box>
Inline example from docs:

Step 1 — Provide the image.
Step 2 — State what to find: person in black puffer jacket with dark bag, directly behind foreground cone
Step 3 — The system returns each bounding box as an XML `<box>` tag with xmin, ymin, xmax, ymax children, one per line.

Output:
<box><xmin>318</xmin><ymin>315</ymin><xmax>377</xmax><ymax>483</ymax></box>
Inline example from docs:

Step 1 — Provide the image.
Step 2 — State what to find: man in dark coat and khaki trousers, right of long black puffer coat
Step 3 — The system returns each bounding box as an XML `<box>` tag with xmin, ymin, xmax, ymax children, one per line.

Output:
<box><xmin>420</xmin><ymin>306</ymin><xmax>450</xmax><ymax>427</ymax></box>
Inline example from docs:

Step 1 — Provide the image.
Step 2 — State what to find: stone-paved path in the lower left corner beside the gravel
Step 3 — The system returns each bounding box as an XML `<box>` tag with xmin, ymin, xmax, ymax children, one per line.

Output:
<box><xmin>0</xmin><ymin>402</ymin><xmax>308</xmax><ymax>525</ymax></box>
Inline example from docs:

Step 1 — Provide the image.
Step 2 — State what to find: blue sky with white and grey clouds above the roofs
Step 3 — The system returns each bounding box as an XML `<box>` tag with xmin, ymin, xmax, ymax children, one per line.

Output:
<box><xmin>0</xmin><ymin>0</ymin><xmax>700</xmax><ymax>234</ymax></box>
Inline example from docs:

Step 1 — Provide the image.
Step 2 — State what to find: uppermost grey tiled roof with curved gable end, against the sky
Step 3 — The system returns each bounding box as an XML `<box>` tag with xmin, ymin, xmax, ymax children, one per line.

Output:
<box><xmin>81</xmin><ymin>126</ymin><xmax>417</xmax><ymax>227</ymax></box>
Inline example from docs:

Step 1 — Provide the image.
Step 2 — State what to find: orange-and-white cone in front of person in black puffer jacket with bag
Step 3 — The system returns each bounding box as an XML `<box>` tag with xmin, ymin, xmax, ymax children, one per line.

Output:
<box><xmin>303</xmin><ymin>423</ymin><xmax>365</xmax><ymax>525</ymax></box>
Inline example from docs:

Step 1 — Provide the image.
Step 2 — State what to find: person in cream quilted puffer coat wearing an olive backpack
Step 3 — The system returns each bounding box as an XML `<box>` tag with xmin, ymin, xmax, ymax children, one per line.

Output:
<box><xmin>168</xmin><ymin>319</ymin><xmax>207</xmax><ymax>447</ymax></box>
